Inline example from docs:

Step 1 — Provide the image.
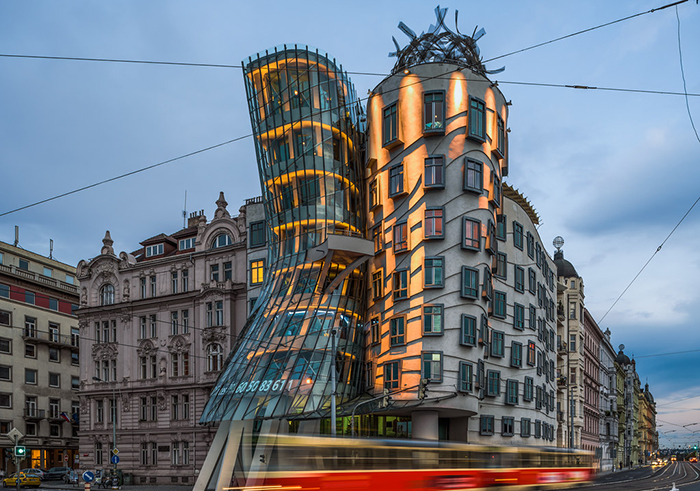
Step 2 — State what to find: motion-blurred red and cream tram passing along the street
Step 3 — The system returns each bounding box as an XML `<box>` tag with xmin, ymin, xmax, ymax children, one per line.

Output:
<box><xmin>237</xmin><ymin>435</ymin><xmax>594</xmax><ymax>491</ymax></box>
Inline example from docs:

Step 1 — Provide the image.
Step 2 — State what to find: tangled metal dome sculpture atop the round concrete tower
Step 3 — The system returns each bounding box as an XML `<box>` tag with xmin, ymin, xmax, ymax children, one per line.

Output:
<box><xmin>389</xmin><ymin>5</ymin><xmax>505</xmax><ymax>74</ymax></box>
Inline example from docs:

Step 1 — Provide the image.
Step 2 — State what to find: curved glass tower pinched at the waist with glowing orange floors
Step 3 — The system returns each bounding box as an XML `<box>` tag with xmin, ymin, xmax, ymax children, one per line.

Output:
<box><xmin>201</xmin><ymin>45</ymin><xmax>373</xmax><ymax>423</ymax></box>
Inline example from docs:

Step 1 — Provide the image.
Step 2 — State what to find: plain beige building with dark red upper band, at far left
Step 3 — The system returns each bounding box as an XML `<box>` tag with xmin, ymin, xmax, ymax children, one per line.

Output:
<box><xmin>0</xmin><ymin>238</ymin><xmax>80</xmax><ymax>474</ymax></box>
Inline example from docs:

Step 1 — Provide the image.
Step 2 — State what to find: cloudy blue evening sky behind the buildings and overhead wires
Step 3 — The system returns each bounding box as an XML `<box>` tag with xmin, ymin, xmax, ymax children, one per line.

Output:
<box><xmin>0</xmin><ymin>0</ymin><xmax>700</xmax><ymax>445</ymax></box>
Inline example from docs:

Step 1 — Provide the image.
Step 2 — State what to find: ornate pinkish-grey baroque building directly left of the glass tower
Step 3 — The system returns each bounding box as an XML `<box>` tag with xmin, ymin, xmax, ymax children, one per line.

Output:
<box><xmin>77</xmin><ymin>193</ymin><xmax>252</xmax><ymax>484</ymax></box>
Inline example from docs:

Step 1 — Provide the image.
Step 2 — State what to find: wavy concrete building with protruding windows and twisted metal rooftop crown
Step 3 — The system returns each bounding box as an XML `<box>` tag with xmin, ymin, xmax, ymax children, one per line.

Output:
<box><xmin>365</xmin><ymin>9</ymin><xmax>556</xmax><ymax>445</ymax></box>
